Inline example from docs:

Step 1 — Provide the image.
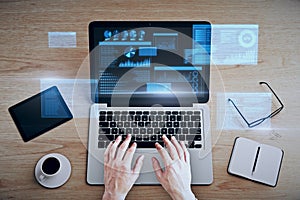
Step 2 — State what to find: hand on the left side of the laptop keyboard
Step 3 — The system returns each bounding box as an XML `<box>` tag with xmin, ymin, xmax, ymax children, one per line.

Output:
<box><xmin>103</xmin><ymin>135</ymin><xmax>144</xmax><ymax>199</ymax></box>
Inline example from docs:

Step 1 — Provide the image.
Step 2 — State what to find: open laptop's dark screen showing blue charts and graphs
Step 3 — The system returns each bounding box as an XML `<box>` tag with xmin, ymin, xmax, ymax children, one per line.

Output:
<box><xmin>89</xmin><ymin>21</ymin><xmax>211</xmax><ymax>106</ymax></box>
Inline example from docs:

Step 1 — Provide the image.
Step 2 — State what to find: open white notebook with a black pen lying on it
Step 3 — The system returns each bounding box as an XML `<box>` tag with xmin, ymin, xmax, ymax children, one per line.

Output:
<box><xmin>227</xmin><ymin>137</ymin><xmax>283</xmax><ymax>187</ymax></box>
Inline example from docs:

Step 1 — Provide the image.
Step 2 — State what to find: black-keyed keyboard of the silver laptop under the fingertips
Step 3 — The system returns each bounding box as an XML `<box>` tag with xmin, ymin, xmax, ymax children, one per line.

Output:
<box><xmin>98</xmin><ymin>110</ymin><xmax>203</xmax><ymax>148</ymax></box>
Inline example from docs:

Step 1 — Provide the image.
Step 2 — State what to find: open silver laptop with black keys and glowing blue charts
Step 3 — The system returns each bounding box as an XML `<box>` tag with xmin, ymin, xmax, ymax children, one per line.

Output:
<box><xmin>87</xmin><ymin>21</ymin><xmax>213</xmax><ymax>185</ymax></box>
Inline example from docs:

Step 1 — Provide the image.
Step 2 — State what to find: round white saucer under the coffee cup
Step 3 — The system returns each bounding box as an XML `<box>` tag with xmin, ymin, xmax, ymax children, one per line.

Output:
<box><xmin>34</xmin><ymin>153</ymin><xmax>71</xmax><ymax>188</ymax></box>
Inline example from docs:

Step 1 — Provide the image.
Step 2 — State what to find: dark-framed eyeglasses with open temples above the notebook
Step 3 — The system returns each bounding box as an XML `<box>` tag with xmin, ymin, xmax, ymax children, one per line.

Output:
<box><xmin>228</xmin><ymin>81</ymin><xmax>284</xmax><ymax>128</ymax></box>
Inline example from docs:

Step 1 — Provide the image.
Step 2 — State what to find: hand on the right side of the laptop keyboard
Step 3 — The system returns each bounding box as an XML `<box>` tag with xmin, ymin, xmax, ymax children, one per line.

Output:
<box><xmin>152</xmin><ymin>135</ymin><xmax>195</xmax><ymax>200</ymax></box>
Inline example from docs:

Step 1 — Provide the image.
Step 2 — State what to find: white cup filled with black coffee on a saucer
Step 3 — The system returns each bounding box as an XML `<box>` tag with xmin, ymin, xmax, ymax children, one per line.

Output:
<box><xmin>38</xmin><ymin>154</ymin><xmax>61</xmax><ymax>182</ymax></box>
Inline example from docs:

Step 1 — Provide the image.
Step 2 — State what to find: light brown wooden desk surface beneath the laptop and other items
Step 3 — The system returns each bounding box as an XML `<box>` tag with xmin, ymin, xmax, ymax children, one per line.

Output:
<box><xmin>0</xmin><ymin>0</ymin><xmax>300</xmax><ymax>199</ymax></box>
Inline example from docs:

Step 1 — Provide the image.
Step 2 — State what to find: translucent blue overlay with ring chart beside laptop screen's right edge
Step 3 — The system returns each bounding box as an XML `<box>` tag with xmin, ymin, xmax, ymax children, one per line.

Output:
<box><xmin>211</xmin><ymin>24</ymin><xmax>258</xmax><ymax>65</ymax></box>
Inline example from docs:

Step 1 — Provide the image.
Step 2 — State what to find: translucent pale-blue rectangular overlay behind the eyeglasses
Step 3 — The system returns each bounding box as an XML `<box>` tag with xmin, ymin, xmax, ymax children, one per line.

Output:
<box><xmin>217</xmin><ymin>93</ymin><xmax>272</xmax><ymax>130</ymax></box>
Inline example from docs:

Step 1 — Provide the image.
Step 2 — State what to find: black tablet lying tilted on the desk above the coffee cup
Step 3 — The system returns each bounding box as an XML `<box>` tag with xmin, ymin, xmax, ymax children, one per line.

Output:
<box><xmin>8</xmin><ymin>86</ymin><xmax>73</xmax><ymax>142</ymax></box>
